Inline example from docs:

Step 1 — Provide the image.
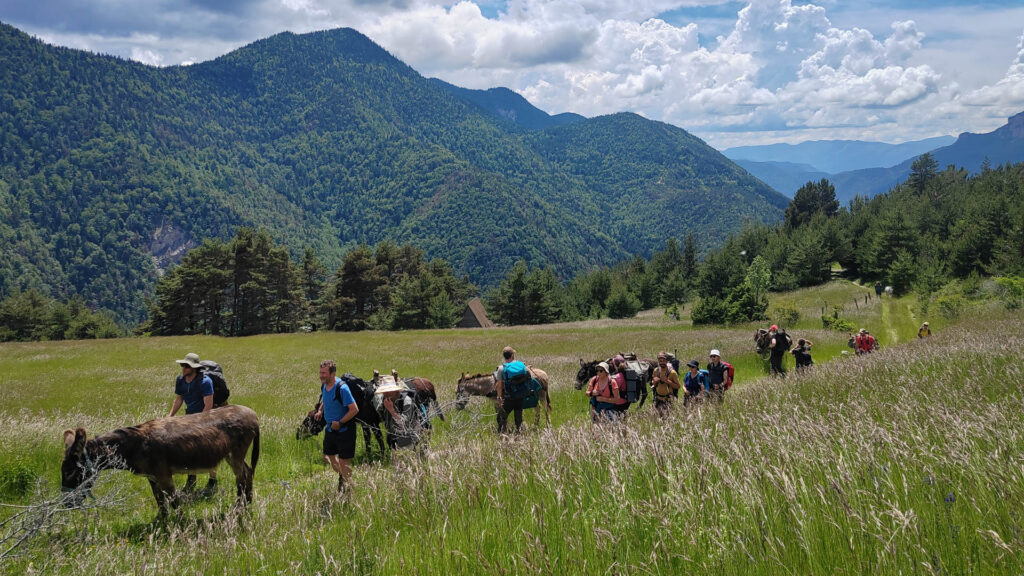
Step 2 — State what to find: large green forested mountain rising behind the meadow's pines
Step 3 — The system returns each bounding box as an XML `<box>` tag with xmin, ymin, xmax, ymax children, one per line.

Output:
<box><xmin>0</xmin><ymin>25</ymin><xmax>786</xmax><ymax>322</ymax></box>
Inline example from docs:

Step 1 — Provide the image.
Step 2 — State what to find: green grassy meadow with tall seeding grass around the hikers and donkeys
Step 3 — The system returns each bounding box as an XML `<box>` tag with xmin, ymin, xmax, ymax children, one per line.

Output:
<box><xmin>0</xmin><ymin>282</ymin><xmax>1024</xmax><ymax>575</ymax></box>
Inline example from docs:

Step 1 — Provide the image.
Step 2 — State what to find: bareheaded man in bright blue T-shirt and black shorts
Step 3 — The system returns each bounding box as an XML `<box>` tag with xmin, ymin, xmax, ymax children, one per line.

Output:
<box><xmin>314</xmin><ymin>360</ymin><xmax>359</xmax><ymax>493</ymax></box>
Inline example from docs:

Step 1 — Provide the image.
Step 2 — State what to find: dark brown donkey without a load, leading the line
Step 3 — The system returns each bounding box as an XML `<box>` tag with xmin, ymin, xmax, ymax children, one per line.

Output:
<box><xmin>60</xmin><ymin>404</ymin><xmax>259</xmax><ymax>517</ymax></box>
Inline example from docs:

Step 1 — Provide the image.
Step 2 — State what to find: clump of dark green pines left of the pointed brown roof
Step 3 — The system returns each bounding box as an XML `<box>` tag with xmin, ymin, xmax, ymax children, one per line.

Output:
<box><xmin>139</xmin><ymin>228</ymin><xmax>476</xmax><ymax>336</ymax></box>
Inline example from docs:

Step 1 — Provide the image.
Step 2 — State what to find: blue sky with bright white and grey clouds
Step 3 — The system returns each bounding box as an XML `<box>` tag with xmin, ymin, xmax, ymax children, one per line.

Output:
<box><xmin>0</xmin><ymin>0</ymin><xmax>1024</xmax><ymax>150</ymax></box>
